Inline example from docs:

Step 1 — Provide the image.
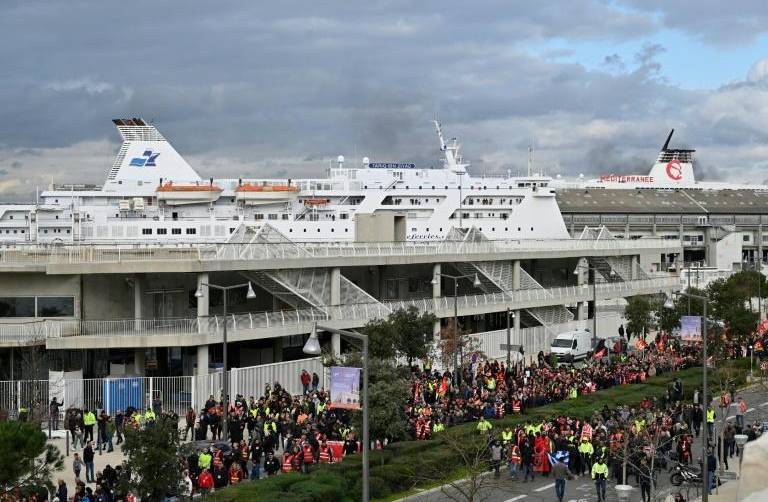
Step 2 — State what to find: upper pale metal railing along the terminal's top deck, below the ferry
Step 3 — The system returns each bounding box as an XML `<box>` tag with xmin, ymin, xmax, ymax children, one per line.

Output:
<box><xmin>0</xmin><ymin>238</ymin><xmax>676</xmax><ymax>264</ymax></box>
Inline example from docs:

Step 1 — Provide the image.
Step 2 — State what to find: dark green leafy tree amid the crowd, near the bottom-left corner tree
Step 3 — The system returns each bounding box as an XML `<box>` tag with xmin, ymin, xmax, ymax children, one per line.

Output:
<box><xmin>120</xmin><ymin>419</ymin><xmax>182</xmax><ymax>501</ymax></box>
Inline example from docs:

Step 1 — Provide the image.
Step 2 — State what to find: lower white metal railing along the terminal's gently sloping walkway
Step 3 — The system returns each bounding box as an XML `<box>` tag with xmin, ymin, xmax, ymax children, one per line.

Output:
<box><xmin>27</xmin><ymin>276</ymin><xmax>681</xmax><ymax>339</ymax></box>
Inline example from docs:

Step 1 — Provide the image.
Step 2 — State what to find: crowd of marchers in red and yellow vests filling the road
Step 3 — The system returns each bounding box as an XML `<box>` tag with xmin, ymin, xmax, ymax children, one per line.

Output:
<box><xmin>22</xmin><ymin>330</ymin><xmax>760</xmax><ymax>502</ymax></box>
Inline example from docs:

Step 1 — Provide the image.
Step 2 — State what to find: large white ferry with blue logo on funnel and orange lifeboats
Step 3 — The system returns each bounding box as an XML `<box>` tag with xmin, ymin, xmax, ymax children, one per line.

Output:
<box><xmin>0</xmin><ymin>118</ymin><xmax>569</xmax><ymax>245</ymax></box>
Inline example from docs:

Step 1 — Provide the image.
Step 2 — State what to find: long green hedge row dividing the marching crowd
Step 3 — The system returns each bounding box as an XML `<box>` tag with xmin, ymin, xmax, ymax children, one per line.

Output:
<box><xmin>211</xmin><ymin>361</ymin><xmax>749</xmax><ymax>502</ymax></box>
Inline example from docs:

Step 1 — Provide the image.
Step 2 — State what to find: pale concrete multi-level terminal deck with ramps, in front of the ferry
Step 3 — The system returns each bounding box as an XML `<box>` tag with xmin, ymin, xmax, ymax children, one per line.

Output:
<box><xmin>0</xmin><ymin>233</ymin><xmax>682</xmax><ymax>378</ymax></box>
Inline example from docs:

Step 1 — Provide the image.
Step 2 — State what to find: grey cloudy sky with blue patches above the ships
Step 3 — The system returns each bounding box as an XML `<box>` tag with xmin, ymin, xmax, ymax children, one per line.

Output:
<box><xmin>0</xmin><ymin>0</ymin><xmax>768</xmax><ymax>201</ymax></box>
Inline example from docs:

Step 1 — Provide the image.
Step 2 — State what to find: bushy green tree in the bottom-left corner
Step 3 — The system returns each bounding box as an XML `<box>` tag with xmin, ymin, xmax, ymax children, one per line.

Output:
<box><xmin>0</xmin><ymin>422</ymin><xmax>64</xmax><ymax>498</ymax></box>
